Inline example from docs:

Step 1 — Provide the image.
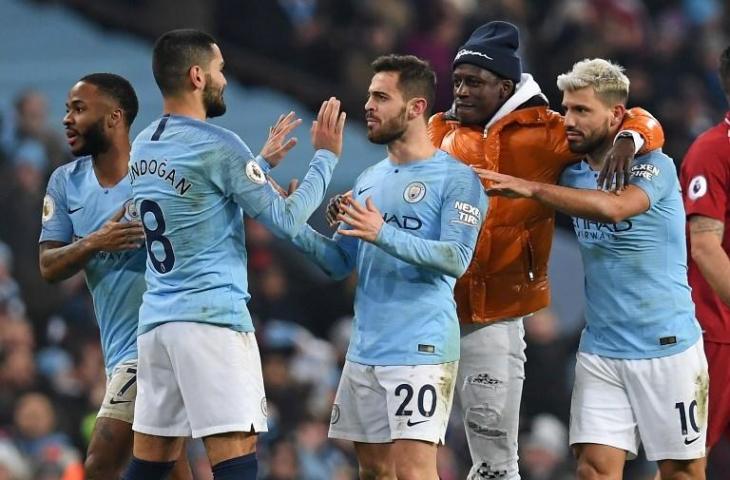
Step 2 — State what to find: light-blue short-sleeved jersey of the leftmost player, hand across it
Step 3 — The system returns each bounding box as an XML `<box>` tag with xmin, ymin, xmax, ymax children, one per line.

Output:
<box><xmin>40</xmin><ymin>157</ymin><xmax>146</xmax><ymax>374</ymax></box>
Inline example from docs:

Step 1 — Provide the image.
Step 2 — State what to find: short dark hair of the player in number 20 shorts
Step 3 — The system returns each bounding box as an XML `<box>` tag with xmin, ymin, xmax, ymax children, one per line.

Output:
<box><xmin>371</xmin><ymin>54</ymin><xmax>436</xmax><ymax>115</ymax></box>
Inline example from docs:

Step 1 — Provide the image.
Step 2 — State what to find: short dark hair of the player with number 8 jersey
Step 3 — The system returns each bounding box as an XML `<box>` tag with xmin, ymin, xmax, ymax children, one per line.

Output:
<box><xmin>152</xmin><ymin>29</ymin><xmax>216</xmax><ymax>95</ymax></box>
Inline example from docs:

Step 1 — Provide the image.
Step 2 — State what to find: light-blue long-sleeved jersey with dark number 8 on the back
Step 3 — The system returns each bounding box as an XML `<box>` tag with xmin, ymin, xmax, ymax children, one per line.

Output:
<box><xmin>129</xmin><ymin>115</ymin><xmax>337</xmax><ymax>334</ymax></box>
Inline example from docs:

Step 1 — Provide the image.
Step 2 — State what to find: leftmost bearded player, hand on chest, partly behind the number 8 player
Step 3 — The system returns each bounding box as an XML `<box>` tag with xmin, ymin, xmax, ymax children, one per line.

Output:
<box><xmin>40</xmin><ymin>73</ymin><xmax>191</xmax><ymax>480</ymax></box>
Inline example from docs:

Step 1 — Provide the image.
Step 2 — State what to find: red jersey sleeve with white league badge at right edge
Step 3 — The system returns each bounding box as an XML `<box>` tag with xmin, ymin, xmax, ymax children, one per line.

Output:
<box><xmin>682</xmin><ymin>143</ymin><xmax>730</xmax><ymax>222</ymax></box>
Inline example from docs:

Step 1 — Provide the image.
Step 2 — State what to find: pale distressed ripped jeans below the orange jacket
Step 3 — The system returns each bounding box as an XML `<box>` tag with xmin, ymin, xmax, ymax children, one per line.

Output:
<box><xmin>455</xmin><ymin>317</ymin><xmax>525</xmax><ymax>480</ymax></box>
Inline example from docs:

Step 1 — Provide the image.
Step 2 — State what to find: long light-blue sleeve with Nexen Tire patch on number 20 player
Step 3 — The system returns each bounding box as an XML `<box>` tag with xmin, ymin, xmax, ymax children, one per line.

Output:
<box><xmin>375</xmin><ymin>165</ymin><xmax>488</xmax><ymax>278</ymax></box>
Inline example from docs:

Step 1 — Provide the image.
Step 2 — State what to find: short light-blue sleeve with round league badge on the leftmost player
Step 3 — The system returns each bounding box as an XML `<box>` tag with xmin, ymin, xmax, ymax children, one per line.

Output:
<box><xmin>39</xmin><ymin>168</ymin><xmax>73</xmax><ymax>243</ymax></box>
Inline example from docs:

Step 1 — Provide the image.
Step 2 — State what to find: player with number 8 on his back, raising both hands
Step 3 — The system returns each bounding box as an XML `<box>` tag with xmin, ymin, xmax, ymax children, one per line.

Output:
<box><xmin>124</xmin><ymin>30</ymin><xmax>345</xmax><ymax>480</ymax></box>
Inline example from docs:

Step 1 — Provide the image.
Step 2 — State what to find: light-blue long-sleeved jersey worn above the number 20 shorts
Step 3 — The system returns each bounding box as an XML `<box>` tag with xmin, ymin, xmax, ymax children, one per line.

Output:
<box><xmin>295</xmin><ymin>150</ymin><xmax>487</xmax><ymax>365</ymax></box>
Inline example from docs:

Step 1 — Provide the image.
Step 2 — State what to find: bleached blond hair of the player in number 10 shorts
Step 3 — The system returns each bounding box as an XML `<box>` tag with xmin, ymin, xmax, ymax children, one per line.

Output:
<box><xmin>558</xmin><ymin>58</ymin><xmax>630</xmax><ymax>105</ymax></box>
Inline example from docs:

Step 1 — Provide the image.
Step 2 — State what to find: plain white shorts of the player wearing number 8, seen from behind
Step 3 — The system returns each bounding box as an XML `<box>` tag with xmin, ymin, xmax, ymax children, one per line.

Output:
<box><xmin>132</xmin><ymin>322</ymin><xmax>267</xmax><ymax>438</ymax></box>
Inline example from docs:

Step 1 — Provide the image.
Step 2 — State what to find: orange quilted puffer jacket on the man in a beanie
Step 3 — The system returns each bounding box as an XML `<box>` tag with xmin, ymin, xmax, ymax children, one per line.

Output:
<box><xmin>429</xmin><ymin>106</ymin><xmax>664</xmax><ymax>323</ymax></box>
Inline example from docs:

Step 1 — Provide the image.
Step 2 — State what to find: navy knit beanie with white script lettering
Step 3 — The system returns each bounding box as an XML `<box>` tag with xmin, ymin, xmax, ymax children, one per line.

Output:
<box><xmin>453</xmin><ymin>22</ymin><xmax>522</xmax><ymax>83</ymax></box>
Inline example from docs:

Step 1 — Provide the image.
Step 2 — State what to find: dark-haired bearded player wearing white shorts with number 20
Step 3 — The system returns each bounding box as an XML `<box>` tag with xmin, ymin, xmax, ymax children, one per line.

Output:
<box><xmin>288</xmin><ymin>55</ymin><xmax>487</xmax><ymax>480</ymax></box>
